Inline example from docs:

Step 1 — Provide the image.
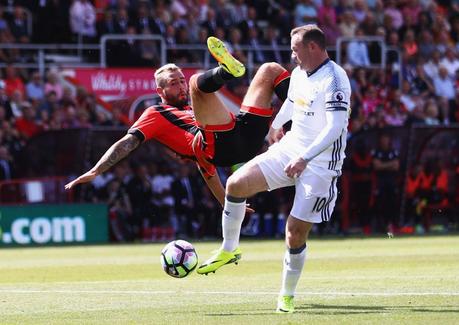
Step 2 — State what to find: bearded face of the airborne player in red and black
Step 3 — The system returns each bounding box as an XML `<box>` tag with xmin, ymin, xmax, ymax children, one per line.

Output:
<box><xmin>158</xmin><ymin>71</ymin><xmax>190</xmax><ymax>107</ymax></box>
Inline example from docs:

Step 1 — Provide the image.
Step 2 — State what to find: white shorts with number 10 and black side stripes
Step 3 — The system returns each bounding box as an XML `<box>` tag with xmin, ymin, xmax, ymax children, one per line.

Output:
<box><xmin>254</xmin><ymin>144</ymin><xmax>338</xmax><ymax>223</ymax></box>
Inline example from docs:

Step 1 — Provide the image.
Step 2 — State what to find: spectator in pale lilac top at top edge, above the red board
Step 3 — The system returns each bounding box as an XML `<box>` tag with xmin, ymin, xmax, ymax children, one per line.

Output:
<box><xmin>70</xmin><ymin>0</ymin><xmax>97</xmax><ymax>43</ymax></box>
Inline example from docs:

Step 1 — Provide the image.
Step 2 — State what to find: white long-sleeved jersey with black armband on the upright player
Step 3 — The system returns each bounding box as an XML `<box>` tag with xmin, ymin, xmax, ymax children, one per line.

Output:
<box><xmin>273</xmin><ymin>60</ymin><xmax>351</xmax><ymax>175</ymax></box>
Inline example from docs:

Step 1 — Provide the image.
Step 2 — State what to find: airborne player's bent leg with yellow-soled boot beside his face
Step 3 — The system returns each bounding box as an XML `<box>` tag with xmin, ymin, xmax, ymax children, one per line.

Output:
<box><xmin>190</xmin><ymin>37</ymin><xmax>245</xmax><ymax>127</ymax></box>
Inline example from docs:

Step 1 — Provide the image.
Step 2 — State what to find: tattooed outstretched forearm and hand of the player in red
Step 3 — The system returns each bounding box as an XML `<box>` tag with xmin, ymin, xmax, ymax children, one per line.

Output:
<box><xmin>65</xmin><ymin>134</ymin><xmax>140</xmax><ymax>190</ymax></box>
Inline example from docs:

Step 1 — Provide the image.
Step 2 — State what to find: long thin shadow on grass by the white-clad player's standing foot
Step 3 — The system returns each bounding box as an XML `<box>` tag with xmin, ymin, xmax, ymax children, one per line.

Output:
<box><xmin>206</xmin><ymin>304</ymin><xmax>459</xmax><ymax>316</ymax></box>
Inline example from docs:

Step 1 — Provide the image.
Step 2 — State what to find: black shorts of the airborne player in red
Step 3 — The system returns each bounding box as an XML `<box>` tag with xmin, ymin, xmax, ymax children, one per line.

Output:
<box><xmin>212</xmin><ymin>111</ymin><xmax>271</xmax><ymax>166</ymax></box>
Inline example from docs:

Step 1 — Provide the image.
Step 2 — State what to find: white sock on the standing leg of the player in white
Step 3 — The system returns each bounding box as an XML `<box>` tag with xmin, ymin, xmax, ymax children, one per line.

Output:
<box><xmin>280</xmin><ymin>244</ymin><xmax>306</xmax><ymax>296</ymax></box>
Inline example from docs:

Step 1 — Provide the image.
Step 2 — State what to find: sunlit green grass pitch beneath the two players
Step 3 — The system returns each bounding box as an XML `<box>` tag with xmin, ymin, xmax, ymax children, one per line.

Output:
<box><xmin>0</xmin><ymin>236</ymin><xmax>459</xmax><ymax>325</ymax></box>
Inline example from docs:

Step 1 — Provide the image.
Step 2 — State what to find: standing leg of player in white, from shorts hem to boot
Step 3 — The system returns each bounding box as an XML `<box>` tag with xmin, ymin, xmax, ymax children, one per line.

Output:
<box><xmin>276</xmin><ymin>216</ymin><xmax>313</xmax><ymax>313</ymax></box>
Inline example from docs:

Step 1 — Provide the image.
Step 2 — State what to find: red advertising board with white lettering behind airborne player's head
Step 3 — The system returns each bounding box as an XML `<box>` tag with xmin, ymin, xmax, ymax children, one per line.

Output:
<box><xmin>74</xmin><ymin>68</ymin><xmax>196</xmax><ymax>97</ymax></box>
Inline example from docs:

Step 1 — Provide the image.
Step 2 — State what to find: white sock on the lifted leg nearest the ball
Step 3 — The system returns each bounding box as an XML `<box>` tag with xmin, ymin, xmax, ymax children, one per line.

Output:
<box><xmin>222</xmin><ymin>197</ymin><xmax>246</xmax><ymax>252</ymax></box>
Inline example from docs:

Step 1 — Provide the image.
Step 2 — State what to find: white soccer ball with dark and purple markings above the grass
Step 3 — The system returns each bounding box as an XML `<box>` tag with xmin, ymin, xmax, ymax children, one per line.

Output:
<box><xmin>161</xmin><ymin>240</ymin><xmax>198</xmax><ymax>278</ymax></box>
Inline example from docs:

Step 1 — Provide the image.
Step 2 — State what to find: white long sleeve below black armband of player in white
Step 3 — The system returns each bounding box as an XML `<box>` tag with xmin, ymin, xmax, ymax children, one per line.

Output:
<box><xmin>302</xmin><ymin>111</ymin><xmax>348</xmax><ymax>161</ymax></box>
